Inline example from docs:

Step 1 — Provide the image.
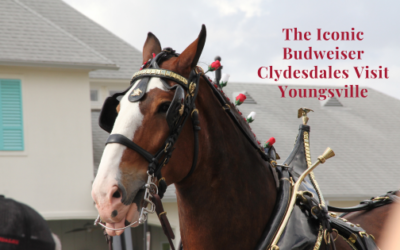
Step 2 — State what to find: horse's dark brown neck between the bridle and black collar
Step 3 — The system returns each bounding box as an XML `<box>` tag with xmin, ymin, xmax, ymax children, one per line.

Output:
<box><xmin>176</xmin><ymin>84</ymin><xmax>276</xmax><ymax>249</ymax></box>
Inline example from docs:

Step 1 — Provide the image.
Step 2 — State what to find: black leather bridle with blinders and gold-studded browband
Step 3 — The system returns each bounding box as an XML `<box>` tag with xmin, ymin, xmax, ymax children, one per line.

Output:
<box><xmin>99</xmin><ymin>48</ymin><xmax>201</xmax><ymax>197</ymax></box>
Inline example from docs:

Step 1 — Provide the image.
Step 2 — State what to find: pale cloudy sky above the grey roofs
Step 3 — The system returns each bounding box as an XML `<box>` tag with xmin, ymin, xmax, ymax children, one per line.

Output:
<box><xmin>64</xmin><ymin>0</ymin><xmax>400</xmax><ymax>99</ymax></box>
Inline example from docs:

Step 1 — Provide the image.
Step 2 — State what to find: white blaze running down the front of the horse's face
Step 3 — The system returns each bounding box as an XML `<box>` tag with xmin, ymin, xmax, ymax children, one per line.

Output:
<box><xmin>92</xmin><ymin>77</ymin><xmax>167</xmax><ymax>204</ymax></box>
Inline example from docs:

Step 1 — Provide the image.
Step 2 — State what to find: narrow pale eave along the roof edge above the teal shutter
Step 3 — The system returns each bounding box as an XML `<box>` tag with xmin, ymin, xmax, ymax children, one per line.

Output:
<box><xmin>0</xmin><ymin>59</ymin><xmax>119</xmax><ymax>70</ymax></box>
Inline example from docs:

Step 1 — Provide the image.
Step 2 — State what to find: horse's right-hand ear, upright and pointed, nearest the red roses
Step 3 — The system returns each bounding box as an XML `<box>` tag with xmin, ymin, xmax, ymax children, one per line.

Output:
<box><xmin>178</xmin><ymin>24</ymin><xmax>207</xmax><ymax>69</ymax></box>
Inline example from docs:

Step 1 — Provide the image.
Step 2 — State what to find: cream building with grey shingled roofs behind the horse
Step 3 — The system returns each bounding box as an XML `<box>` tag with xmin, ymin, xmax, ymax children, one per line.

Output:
<box><xmin>0</xmin><ymin>0</ymin><xmax>400</xmax><ymax>250</ymax></box>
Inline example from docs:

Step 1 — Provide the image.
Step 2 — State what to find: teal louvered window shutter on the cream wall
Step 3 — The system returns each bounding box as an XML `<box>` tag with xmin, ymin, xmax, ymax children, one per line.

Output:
<box><xmin>0</xmin><ymin>79</ymin><xmax>24</xmax><ymax>151</ymax></box>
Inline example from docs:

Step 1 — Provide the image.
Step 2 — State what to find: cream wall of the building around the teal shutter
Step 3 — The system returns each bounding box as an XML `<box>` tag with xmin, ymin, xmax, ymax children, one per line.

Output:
<box><xmin>0</xmin><ymin>66</ymin><xmax>96</xmax><ymax>219</ymax></box>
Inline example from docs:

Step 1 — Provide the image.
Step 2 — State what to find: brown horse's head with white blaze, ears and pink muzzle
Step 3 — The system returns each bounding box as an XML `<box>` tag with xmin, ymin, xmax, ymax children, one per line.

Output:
<box><xmin>92</xmin><ymin>25</ymin><xmax>206</xmax><ymax>236</ymax></box>
